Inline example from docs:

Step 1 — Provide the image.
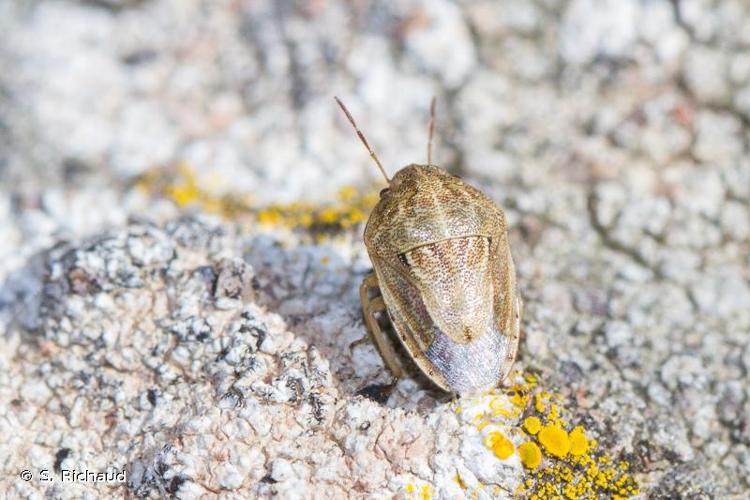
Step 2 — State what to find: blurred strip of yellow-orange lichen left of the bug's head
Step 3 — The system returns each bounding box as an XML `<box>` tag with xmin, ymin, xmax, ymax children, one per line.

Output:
<box><xmin>136</xmin><ymin>163</ymin><xmax>378</xmax><ymax>235</ymax></box>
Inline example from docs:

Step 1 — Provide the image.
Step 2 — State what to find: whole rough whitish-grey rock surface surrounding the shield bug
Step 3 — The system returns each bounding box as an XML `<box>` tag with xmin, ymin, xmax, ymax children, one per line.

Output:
<box><xmin>0</xmin><ymin>0</ymin><xmax>750</xmax><ymax>498</ymax></box>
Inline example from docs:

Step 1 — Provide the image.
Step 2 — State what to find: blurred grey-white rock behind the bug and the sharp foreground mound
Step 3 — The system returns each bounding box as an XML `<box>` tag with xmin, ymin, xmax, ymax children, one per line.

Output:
<box><xmin>0</xmin><ymin>0</ymin><xmax>750</xmax><ymax>496</ymax></box>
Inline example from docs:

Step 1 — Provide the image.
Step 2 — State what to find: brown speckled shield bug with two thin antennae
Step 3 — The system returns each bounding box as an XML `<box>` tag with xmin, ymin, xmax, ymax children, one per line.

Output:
<box><xmin>336</xmin><ymin>98</ymin><xmax>522</xmax><ymax>393</ymax></box>
